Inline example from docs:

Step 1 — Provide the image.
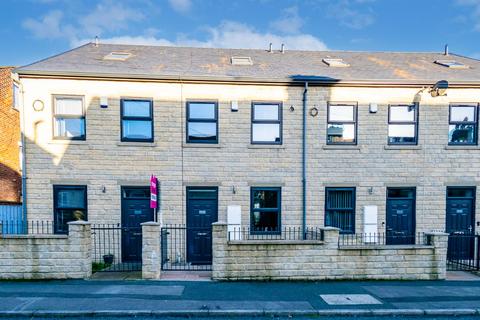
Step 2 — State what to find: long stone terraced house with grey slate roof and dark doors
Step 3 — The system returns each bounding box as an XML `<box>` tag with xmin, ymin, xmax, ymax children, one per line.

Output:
<box><xmin>10</xmin><ymin>43</ymin><xmax>480</xmax><ymax>272</ymax></box>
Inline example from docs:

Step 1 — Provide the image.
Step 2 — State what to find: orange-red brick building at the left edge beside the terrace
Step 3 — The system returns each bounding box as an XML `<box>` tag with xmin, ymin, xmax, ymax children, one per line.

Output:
<box><xmin>0</xmin><ymin>67</ymin><xmax>22</xmax><ymax>204</ymax></box>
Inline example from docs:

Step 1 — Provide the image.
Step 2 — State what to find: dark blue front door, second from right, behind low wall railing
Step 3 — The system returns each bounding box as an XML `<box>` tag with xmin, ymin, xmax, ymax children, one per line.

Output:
<box><xmin>386</xmin><ymin>188</ymin><xmax>415</xmax><ymax>244</ymax></box>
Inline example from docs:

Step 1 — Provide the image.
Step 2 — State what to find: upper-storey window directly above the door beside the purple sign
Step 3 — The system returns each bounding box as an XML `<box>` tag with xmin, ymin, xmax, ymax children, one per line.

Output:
<box><xmin>121</xmin><ymin>99</ymin><xmax>153</xmax><ymax>142</ymax></box>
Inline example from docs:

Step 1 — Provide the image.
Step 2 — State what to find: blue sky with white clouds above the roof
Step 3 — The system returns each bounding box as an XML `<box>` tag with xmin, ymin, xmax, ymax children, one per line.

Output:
<box><xmin>0</xmin><ymin>0</ymin><xmax>480</xmax><ymax>65</ymax></box>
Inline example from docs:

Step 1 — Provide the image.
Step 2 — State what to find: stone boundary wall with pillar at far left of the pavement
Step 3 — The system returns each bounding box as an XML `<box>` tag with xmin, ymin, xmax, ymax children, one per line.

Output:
<box><xmin>0</xmin><ymin>221</ymin><xmax>92</xmax><ymax>279</ymax></box>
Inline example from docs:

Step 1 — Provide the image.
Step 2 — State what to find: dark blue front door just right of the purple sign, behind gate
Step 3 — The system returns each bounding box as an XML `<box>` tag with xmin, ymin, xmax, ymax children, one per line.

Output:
<box><xmin>187</xmin><ymin>187</ymin><xmax>218</xmax><ymax>264</ymax></box>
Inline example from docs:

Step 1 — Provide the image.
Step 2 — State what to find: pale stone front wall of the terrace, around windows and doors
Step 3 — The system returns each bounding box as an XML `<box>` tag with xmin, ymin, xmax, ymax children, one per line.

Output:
<box><xmin>17</xmin><ymin>78</ymin><xmax>480</xmax><ymax>232</ymax></box>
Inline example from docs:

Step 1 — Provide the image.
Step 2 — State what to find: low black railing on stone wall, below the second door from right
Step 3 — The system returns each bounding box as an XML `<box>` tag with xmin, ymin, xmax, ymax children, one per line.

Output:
<box><xmin>338</xmin><ymin>232</ymin><xmax>428</xmax><ymax>247</ymax></box>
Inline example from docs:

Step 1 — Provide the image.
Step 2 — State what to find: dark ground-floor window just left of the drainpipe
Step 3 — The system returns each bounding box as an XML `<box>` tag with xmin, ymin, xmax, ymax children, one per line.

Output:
<box><xmin>250</xmin><ymin>187</ymin><xmax>281</xmax><ymax>234</ymax></box>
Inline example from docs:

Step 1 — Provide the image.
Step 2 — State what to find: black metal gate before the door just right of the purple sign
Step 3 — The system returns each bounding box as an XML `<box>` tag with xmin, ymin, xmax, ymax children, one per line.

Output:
<box><xmin>161</xmin><ymin>225</ymin><xmax>212</xmax><ymax>271</ymax></box>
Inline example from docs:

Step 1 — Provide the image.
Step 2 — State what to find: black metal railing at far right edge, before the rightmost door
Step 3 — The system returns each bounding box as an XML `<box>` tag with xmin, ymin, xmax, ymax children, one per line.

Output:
<box><xmin>447</xmin><ymin>234</ymin><xmax>480</xmax><ymax>271</ymax></box>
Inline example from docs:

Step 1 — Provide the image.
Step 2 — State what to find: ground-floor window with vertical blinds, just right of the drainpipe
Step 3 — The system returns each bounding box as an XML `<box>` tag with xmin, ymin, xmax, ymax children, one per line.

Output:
<box><xmin>325</xmin><ymin>188</ymin><xmax>355</xmax><ymax>233</ymax></box>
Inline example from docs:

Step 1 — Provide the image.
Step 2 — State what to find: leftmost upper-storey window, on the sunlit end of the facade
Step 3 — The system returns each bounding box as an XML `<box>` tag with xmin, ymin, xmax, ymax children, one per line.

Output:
<box><xmin>53</xmin><ymin>96</ymin><xmax>86</xmax><ymax>140</ymax></box>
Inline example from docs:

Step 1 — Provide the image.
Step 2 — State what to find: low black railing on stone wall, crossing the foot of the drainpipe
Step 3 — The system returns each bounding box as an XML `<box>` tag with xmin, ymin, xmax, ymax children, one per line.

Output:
<box><xmin>228</xmin><ymin>227</ymin><xmax>323</xmax><ymax>241</ymax></box>
